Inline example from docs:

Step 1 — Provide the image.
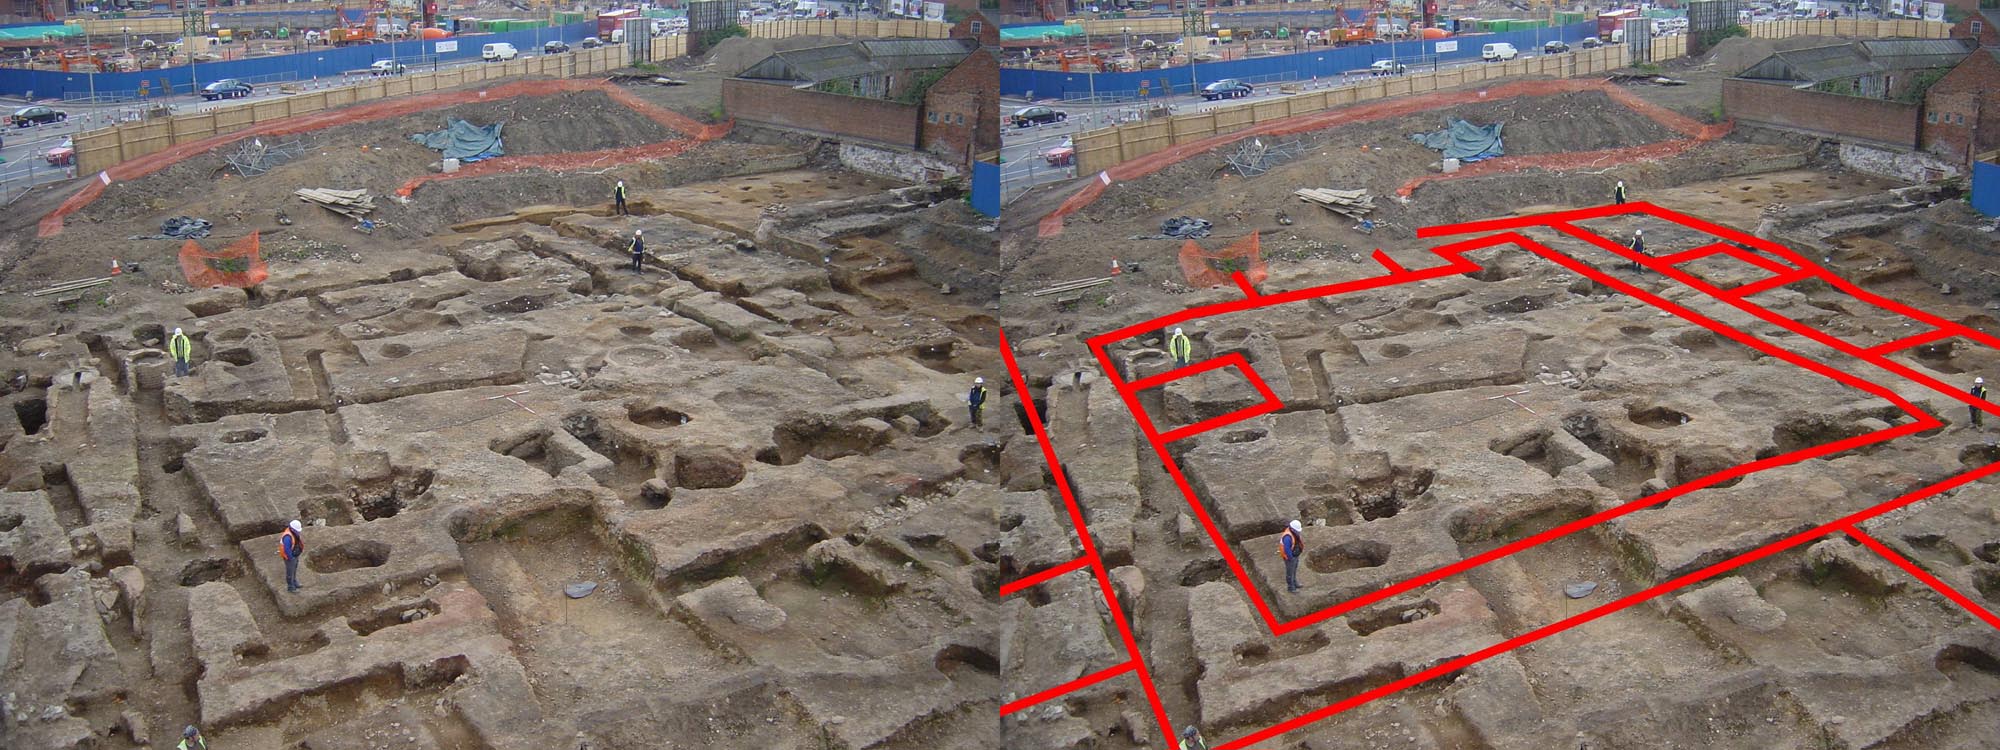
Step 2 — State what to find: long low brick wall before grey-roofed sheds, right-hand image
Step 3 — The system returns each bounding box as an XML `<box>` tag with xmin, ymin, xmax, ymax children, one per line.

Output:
<box><xmin>1722</xmin><ymin>78</ymin><xmax>1922</xmax><ymax>148</ymax></box>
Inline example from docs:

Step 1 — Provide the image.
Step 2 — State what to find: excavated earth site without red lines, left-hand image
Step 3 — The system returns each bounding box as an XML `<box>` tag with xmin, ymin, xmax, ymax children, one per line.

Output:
<box><xmin>0</xmin><ymin>66</ymin><xmax>1000</xmax><ymax>750</ymax></box>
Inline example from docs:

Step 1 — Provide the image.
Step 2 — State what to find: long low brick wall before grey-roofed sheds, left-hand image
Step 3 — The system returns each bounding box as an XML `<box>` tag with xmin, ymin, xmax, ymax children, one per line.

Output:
<box><xmin>722</xmin><ymin>78</ymin><xmax>922</xmax><ymax>148</ymax></box>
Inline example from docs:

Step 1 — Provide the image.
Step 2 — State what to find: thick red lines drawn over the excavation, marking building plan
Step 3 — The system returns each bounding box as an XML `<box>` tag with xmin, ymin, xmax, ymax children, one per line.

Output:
<box><xmin>1000</xmin><ymin>202</ymin><xmax>2000</xmax><ymax>750</ymax></box>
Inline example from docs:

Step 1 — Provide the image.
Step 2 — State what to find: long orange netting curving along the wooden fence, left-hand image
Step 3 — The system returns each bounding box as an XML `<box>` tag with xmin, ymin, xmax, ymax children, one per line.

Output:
<box><xmin>36</xmin><ymin>80</ymin><xmax>732</xmax><ymax>238</ymax></box>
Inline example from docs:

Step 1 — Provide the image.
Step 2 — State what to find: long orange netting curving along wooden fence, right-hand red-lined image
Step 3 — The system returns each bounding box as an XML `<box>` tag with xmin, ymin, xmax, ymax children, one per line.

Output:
<box><xmin>1036</xmin><ymin>80</ymin><xmax>1730</xmax><ymax>238</ymax></box>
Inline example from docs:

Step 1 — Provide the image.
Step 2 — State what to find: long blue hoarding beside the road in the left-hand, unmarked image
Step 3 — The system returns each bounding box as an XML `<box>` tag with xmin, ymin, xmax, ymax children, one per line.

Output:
<box><xmin>0</xmin><ymin>22</ymin><xmax>596</xmax><ymax>100</ymax></box>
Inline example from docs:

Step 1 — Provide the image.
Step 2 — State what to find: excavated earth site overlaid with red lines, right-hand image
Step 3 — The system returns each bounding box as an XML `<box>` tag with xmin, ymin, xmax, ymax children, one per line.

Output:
<box><xmin>998</xmin><ymin>36</ymin><xmax>2000</xmax><ymax>750</ymax></box>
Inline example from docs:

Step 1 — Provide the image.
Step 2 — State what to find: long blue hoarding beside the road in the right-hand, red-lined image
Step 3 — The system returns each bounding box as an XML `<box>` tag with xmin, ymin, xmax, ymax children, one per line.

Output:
<box><xmin>1000</xmin><ymin>22</ymin><xmax>1596</xmax><ymax>100</ymax></box>
